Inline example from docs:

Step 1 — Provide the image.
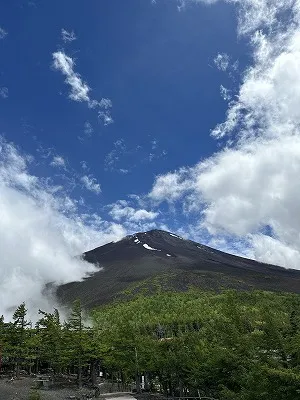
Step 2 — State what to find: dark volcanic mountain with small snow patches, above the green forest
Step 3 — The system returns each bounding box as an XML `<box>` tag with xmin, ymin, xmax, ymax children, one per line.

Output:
<box><xmin>57</xmin><ymin>230</ymin><xmax>300</xmax><ymax>307</ymax></box>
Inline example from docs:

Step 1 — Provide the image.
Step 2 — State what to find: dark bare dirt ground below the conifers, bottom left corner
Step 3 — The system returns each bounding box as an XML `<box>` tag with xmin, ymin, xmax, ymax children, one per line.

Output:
<box><xmin>0</xmin><ymin>377</ymin><xmax>98</xmax><ymax>400</ymax></box>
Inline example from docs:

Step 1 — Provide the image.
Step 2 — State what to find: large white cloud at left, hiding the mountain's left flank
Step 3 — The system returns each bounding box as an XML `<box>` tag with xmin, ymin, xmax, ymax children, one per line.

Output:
<box><xmin>0</xmin><ymin>139</ymin><xmax>127</xmax><ymax>317</ymax></box>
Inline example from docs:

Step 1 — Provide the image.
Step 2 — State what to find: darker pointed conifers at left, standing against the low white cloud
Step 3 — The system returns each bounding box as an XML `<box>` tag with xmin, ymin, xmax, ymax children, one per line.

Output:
<box><xmin>0</xmin><ymin>300</ymin><xmax>94</xmax><ymax>387</ymax></box>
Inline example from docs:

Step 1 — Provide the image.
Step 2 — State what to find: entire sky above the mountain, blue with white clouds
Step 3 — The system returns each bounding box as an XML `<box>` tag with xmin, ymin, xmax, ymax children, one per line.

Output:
<box><xmin>0</xmin><ymin>0</ymin><xmax>300</xmax><ymax>316</ymax></box>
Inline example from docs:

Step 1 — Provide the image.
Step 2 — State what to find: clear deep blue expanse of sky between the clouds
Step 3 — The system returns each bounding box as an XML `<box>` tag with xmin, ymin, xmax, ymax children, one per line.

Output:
<box><xmin>0</xmin><ymin>0</ymin><xmax>247</xmax><ymax>206</ymax></box>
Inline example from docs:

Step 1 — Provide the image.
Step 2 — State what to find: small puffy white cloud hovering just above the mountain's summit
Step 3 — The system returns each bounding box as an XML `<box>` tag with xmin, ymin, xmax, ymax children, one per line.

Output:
<box><xmin>109</xmin><ymin>200</ymin><xmax>159</xmax><ymax>223</ymax></box>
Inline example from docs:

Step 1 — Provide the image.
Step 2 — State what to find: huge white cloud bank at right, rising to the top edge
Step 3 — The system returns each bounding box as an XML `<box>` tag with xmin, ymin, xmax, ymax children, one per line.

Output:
<box><xmin>150</xmin><ymin>0</ymin><xmax>300</xmax><ymax>269</ymax></box>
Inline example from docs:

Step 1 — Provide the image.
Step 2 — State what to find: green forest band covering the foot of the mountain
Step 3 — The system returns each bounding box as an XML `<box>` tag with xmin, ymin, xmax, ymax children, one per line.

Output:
<box><xmin>0</xmin><ymin>290</ymin><xmax>300</xmax><ymax>400</ymax></box>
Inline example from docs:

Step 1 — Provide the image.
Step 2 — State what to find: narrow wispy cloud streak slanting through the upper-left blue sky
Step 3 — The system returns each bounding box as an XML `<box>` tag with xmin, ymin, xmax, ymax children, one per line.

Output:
<box><xmin>52</xmin><ymin>51</ymin><xmax>113</xmax><ymax>125</ymax></box>
